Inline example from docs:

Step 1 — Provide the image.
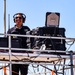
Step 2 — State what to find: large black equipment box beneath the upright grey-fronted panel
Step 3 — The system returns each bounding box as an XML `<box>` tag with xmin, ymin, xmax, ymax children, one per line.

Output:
<box><xmin>32</xmin><ymin>27</ymin><xmax>66</xmax><ymax>54</ymax></box>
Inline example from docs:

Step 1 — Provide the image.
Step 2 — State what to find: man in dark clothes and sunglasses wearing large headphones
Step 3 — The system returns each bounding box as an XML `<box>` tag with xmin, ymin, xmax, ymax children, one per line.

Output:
<box><xmin>8</xmin><ymin>13</ymin><xmax>30</xmax><ymax>75</ymax></box>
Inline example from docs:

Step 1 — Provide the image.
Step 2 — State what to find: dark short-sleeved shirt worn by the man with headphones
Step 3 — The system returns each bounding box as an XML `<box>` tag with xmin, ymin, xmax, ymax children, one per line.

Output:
<box><xmin>7</xmin><ymin>25</ymin><xmax>30</xmax><ymax>48</ymax></box>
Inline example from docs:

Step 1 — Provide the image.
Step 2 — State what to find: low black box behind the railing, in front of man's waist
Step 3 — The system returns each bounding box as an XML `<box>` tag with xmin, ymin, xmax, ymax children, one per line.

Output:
<box><xmin>0</xmin><ymin>37</ymin><xmax>22</xmax><ymax>52</ymax></box>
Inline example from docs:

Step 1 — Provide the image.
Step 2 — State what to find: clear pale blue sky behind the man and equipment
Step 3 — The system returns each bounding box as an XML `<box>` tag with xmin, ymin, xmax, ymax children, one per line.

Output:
<box><xmin>0</xmin><ymin>0</ymin><xmax>75</xmax><ymax>74</ymax></box>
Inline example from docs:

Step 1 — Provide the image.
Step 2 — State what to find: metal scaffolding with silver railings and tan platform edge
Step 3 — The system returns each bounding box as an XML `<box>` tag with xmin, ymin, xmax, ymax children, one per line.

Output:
<box><xmin>0</xmin><ymin>34</ymin><xmax>75</xmax><ymax>75</ymax></box>
